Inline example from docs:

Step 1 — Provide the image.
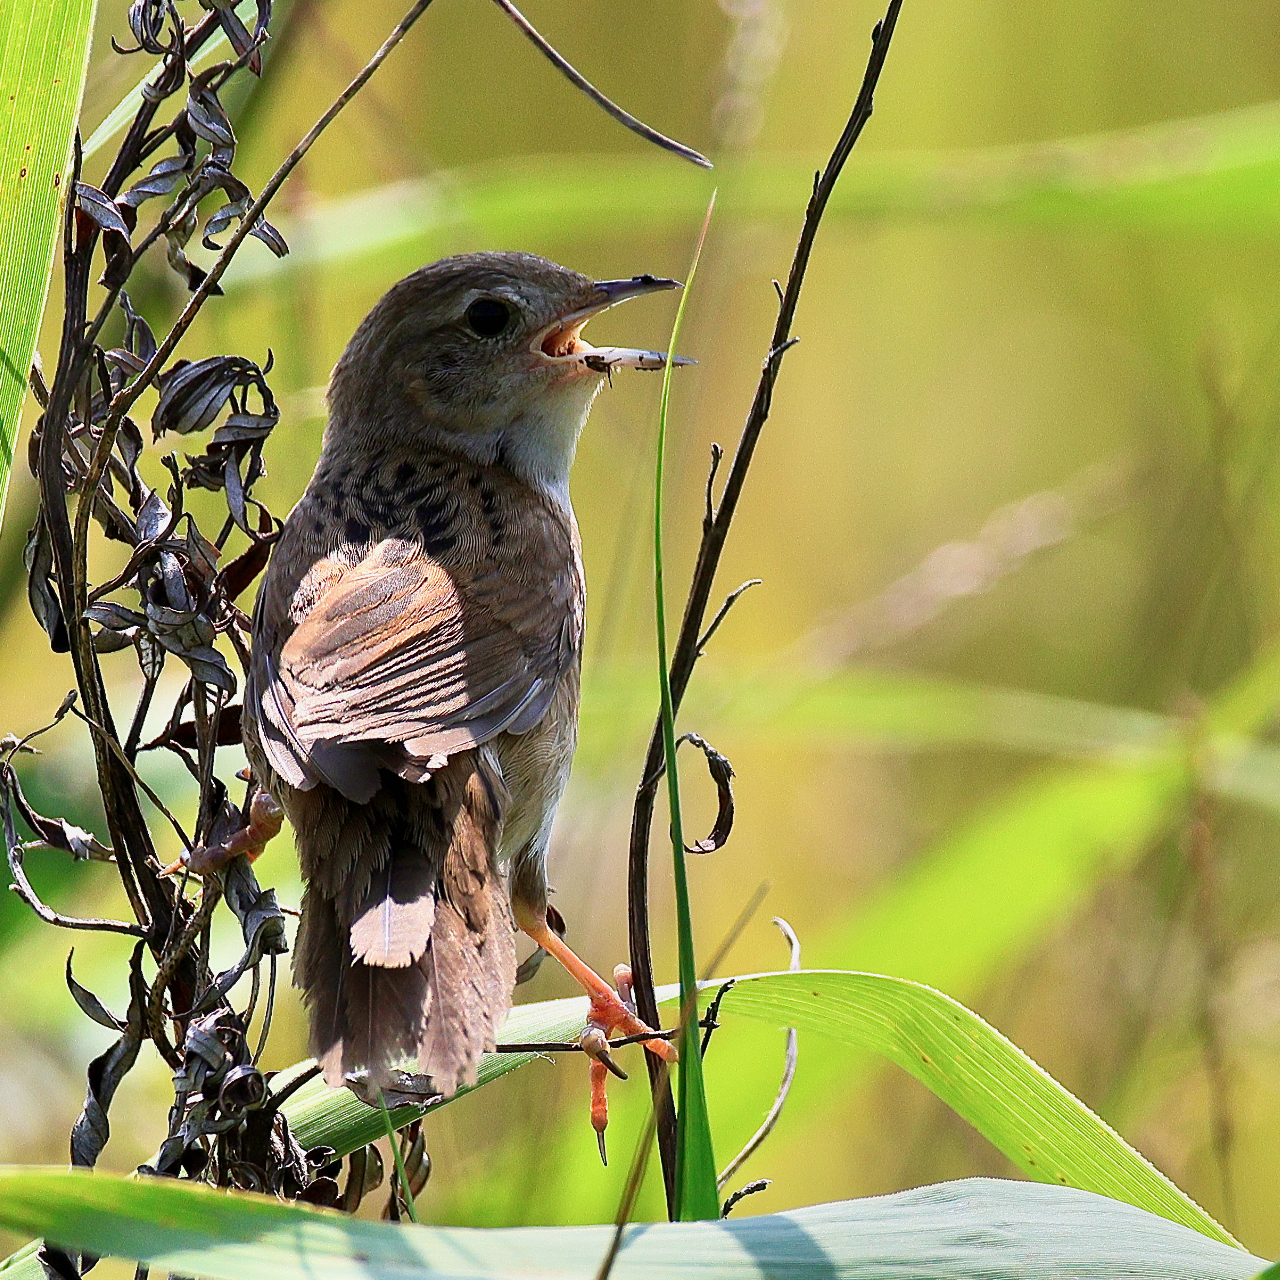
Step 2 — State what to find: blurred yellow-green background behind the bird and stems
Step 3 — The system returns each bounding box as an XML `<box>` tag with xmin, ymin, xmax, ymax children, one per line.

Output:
<box><xmin>0</xmin><ymin>0</ymin><xmax>1280</xmax><ymax>1256</ymax></box>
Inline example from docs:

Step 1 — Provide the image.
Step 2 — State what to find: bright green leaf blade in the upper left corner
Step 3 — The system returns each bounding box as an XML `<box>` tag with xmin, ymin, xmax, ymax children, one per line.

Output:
<box><xmin>0</xmin><ymin>0</ymin><xmax>93</xmax><ymax>527</ymax></box>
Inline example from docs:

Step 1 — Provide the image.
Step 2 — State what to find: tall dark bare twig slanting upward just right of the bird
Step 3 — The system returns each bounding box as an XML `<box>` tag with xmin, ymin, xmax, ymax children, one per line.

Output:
<box><xmin>627</xmin><ymin>0</ymin><xmax>901</xmax><ymax>1212</ymax></box>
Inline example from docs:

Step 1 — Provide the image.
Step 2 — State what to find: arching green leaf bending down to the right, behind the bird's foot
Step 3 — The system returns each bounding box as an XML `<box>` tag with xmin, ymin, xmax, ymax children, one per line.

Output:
<box><xmin>273</xmin><ymin>970</ymin><xmax>1234</xmax><ymax>1243</ymax></box>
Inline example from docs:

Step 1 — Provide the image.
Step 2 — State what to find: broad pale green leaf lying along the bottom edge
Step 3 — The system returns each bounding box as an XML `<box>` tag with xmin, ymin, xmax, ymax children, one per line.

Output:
<box><xmin>0</xmin><ymin>1169</ymin><xmax>1265</xmax><ymax>1280</ymax></box>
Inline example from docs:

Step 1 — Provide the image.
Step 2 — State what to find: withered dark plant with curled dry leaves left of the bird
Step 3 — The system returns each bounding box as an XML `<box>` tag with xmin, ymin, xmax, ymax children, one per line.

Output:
<box><xmin>15</xmin><ymin>0</ymin><xmax>705</xmax><ymax>1254</ymax></box>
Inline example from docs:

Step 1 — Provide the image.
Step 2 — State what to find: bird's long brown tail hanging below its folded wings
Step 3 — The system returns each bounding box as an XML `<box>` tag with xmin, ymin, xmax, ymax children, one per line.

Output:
<box><xmin>294</xmin><ymin>751</ymin><xmax>516</xmax><ymax>1101</ymax></box>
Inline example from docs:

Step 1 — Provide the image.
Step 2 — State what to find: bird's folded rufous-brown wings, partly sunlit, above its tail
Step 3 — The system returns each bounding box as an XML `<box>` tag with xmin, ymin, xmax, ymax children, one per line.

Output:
<box><xmin>259</xmin><ymin>512</ymin><xmax>581</xmax><ymax>799</ymax></box>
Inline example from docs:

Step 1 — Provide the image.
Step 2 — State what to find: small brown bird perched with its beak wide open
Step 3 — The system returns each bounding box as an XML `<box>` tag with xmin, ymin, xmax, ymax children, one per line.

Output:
<box><xmin>244</xmin><ymin>253</ymin><xmax>678</xmax><ymax>1129</ymax></box>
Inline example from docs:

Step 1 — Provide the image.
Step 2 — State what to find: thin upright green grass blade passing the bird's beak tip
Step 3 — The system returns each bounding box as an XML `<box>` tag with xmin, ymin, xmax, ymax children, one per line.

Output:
<box><xmin>653</xmin><ymin>192</ymin><xmax>719</xmax><ymax>1222</ymax></box>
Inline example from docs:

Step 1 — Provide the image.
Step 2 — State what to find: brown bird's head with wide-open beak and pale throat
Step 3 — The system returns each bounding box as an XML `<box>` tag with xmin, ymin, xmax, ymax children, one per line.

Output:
<box><xmin>329</xmin><ymin>253</ymin><xmax>689</xmax><ymax>500</ymax></box>
